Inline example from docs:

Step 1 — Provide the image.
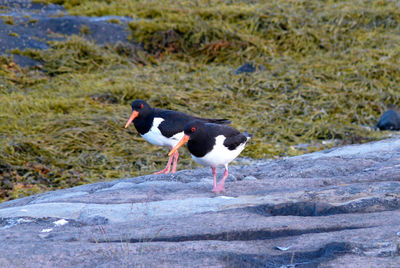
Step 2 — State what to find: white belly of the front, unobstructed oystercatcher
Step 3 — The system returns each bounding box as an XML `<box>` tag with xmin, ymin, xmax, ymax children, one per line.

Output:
<box><xmin>192</xmin><ymin>135</ymin><xmax>246</xmax><ymax>167</ymax></box>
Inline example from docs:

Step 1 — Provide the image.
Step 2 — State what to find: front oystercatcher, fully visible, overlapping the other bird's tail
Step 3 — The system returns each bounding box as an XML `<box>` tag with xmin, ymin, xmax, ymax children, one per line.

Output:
<box><xmin>168</xmin><ymin>121</ymin><xmax>251</xmax><ymax>194</ymax></box>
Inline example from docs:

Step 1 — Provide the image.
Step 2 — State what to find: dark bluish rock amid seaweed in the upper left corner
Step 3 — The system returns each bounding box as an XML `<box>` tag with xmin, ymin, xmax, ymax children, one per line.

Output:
<box><xmin>0</xmin><ymin>0</ymin><xmax>133</xmax><ymax>66</ymax></box>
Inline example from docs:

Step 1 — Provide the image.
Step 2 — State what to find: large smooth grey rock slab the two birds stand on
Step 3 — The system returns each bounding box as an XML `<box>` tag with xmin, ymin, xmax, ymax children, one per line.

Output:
<box><xmin>0</xmin><ymin>137</ymin><xmax>400</xmax><ymax>267</ymax></box>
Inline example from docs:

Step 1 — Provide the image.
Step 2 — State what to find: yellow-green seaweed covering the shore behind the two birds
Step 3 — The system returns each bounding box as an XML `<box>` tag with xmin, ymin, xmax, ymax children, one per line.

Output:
<box><xmin>0</xmin><ymin>0</ymin><xmax>400</xmax><ymax>200</ymax></box>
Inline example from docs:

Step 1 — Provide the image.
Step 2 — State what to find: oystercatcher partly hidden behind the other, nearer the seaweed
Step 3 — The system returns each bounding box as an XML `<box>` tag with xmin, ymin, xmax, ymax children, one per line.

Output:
<box><xmin>125</xmin><ymin>100</ymin><xmax>231</xmax><ymax>174</ymax></box>
